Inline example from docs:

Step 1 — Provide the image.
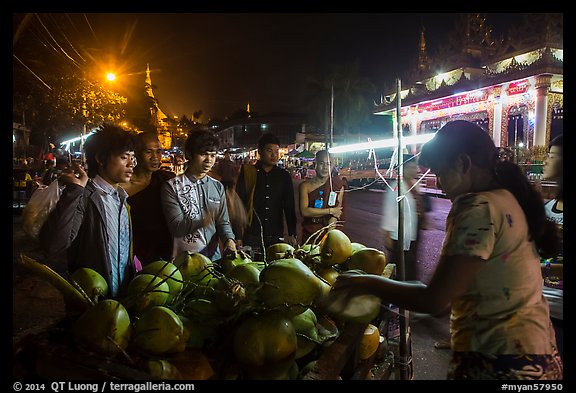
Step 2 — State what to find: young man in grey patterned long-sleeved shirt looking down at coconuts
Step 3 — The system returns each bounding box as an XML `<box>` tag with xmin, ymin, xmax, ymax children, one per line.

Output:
<box><xmin>161</xmin><ymin>131</ymin><xmax>236</xmax><ymax>261</ymax></box>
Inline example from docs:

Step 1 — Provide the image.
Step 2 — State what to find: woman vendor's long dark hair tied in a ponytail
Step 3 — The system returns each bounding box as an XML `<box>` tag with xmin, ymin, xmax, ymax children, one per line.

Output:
<box><xmin>420</xmin><ymin>120</ymin><xmax>560</xmax><ymax>258</ymax></box>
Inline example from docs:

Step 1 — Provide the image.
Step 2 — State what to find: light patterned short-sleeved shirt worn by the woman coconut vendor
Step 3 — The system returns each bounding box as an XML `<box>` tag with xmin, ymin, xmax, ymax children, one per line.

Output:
<box><xmin>442</xmin><ymin>189</ymin><xmax>554</xmax><ymax>355</ymax></box>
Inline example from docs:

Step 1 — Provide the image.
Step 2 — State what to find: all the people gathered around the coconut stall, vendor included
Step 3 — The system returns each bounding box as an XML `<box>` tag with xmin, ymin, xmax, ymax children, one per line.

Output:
<box><xmin>27</xmin><ymin>121</ymin><xmax>563</xmax><ymax>379</ymax></box>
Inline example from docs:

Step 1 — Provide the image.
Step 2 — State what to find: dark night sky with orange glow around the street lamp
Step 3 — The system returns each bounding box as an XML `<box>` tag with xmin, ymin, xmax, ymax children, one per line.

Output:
<box><xmin>14</xmin><ymin>13</ymin><xmax>519</xmax><ymax>121</ymax></box>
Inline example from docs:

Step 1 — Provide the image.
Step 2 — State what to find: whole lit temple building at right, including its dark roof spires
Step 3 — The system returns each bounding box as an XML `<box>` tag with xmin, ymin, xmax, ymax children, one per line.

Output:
<box><xmin>373</xmin><ymin>14</ymin><xmax>564</xmax><ymax>162</ymax></box>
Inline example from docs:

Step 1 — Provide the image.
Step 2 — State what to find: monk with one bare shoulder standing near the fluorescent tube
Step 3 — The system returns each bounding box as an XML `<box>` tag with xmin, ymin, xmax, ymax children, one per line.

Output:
<box><xmin>298</xmin><ymin>150</ymin><xmax>345</xmax><ymax>243</ymax></box>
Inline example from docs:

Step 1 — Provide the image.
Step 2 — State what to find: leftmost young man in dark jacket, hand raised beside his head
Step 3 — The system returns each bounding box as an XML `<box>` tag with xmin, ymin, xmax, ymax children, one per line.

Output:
<box><xmin>39</xmin><ymin>124</ymin><xmax>136</xmax><ymax>298</ymax></box>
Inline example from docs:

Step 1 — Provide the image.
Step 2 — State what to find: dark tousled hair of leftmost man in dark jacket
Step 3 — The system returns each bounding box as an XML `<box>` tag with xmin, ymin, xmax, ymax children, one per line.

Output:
<box><xmin>84</xmin><ymin>123</ymin><xmax>135</xmax><ymax>178</ymax></box>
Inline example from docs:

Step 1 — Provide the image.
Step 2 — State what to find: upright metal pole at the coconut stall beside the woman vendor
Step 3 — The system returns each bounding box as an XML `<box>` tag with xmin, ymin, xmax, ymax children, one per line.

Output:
<box><xmin>396</xmin><ymin>78</ymin><xmax>413</xmax><ymax>380</ymax></box>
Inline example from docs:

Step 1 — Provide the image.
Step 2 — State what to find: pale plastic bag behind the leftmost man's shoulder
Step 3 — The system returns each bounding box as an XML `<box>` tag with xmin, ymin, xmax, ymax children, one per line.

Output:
<box><xmin>22</xmin><ymin>180</ymin><xmax>62</xmax><ymax>240</ymax></box>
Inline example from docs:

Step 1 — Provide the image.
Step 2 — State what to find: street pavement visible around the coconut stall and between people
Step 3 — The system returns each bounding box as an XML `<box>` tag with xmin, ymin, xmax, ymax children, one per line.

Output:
<box><xmin>12</xmin><ymin>182</ymin><xmax>451</xmax><ymax>380</ymax></box>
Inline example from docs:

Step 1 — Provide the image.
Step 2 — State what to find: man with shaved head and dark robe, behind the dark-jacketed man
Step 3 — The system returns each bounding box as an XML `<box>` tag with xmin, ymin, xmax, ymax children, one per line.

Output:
<box><xmin>121</xmin><ymin>132</ymin><xmax>176</xmax><ymax>266</ymax></box>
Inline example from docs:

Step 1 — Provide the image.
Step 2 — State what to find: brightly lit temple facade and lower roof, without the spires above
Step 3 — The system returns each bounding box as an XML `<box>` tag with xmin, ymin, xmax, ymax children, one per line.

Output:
<box><xmin>374</xmin><ymin>47</ymin><xmax>563</xmax><ymax>160</ymax></box>
